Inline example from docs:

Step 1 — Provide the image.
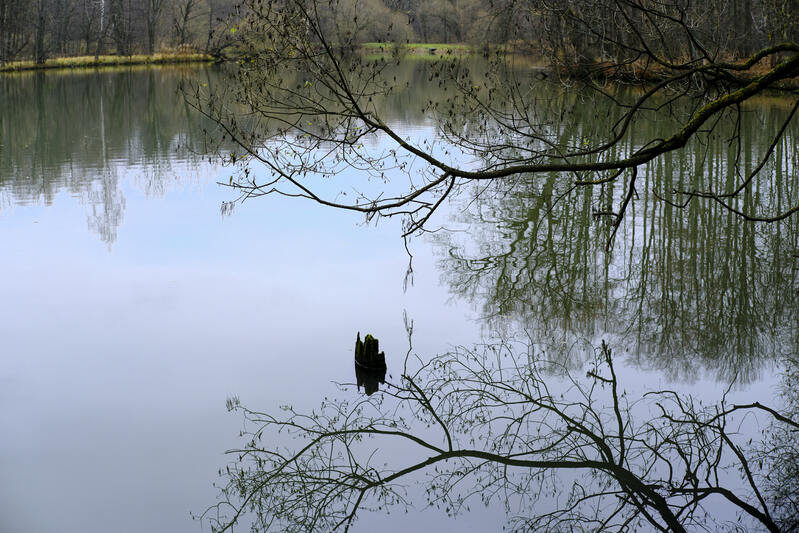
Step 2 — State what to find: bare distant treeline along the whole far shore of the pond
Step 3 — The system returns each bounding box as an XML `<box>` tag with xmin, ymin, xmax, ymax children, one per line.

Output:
<box><xmin>0</xmin><ymin>0</ymin><xmax>799</xmax><ymax>64</ymax></box>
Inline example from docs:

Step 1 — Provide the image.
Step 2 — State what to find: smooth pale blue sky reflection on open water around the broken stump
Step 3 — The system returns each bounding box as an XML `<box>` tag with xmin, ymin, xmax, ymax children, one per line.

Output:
<box><xmin>0</xmin><ymin>66</ymin><xmax>792</xmax><ymax>533</ymax></box>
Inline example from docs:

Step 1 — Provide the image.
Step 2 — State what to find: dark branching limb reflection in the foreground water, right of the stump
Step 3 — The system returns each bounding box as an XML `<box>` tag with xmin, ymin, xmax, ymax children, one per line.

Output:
<box><xmin>204</xmin><ymin>340</ymin><xmax>799</xmax><ymax>531</ymax></box>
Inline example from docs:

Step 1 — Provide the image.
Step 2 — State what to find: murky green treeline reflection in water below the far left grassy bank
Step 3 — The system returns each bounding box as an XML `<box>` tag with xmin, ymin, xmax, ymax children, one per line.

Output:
<box><xmin>0</xmin><ymin>65</ymin><xmax>219</xmax><ymax>245</ymax></box>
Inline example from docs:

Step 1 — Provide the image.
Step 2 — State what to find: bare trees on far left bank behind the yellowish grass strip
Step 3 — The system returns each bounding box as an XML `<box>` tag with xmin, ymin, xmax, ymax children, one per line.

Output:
<box><xmin>0</xmin><ymin>0</ymin><xmax>237</xmax><ymax>64</ymax></box>
